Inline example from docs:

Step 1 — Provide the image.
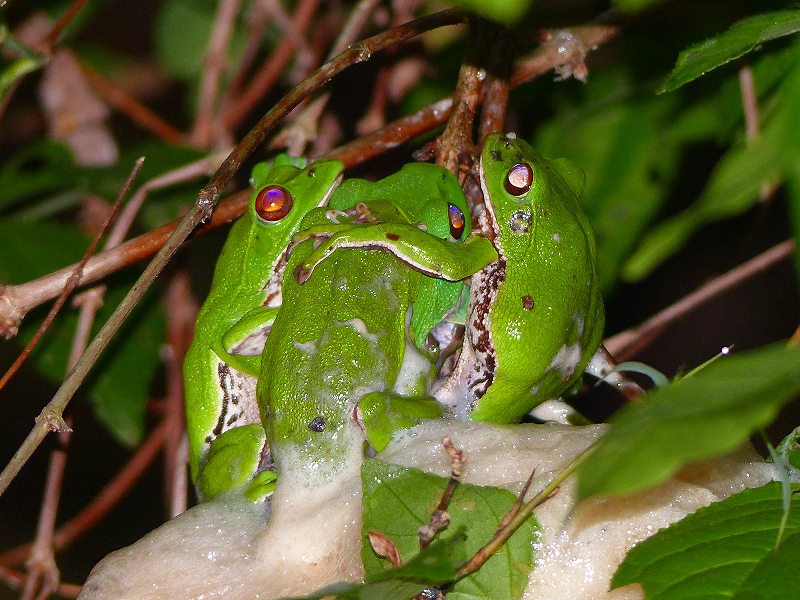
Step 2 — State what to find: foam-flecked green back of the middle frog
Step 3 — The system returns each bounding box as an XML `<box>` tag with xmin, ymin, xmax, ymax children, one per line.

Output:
<box><xmin>258</xmin><ymin>234</ymin><xmax>413</xmax><ymax>478</ymax></box>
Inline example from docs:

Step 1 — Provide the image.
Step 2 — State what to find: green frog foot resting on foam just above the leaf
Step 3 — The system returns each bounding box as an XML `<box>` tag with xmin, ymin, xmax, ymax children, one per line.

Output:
<box><xmin>358</xmin><ymin>392</ymin><xmax>442</xmax><ymax>452</ymax></box>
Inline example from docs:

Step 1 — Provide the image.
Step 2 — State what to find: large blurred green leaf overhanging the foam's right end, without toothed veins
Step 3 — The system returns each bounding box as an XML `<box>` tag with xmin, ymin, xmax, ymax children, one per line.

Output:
<box><xmin>578</xmin><ymin>344</ymin><xmax>800</xmax><ymax>498</ymax></box>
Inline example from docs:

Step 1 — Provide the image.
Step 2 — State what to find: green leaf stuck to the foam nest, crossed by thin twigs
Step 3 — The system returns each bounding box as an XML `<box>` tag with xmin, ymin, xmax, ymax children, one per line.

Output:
<box><xmin>362</xmin><ymin>459</ymin><xmax>539</xmax><ymax>600</ymax></box>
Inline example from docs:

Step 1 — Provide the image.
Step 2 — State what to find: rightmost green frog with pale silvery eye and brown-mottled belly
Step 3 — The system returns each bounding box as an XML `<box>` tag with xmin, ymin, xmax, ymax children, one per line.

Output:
<box><xmin>434</xmin><ymin>134</ymin><xmax>605</xmax><ymax>423</ymax></box>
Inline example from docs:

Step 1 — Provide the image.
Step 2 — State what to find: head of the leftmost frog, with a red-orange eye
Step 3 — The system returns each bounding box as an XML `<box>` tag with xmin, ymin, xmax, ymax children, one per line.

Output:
<box><xmin>248</xmin><ymin>155</ymin><xmax>344</xmax><ymax>233</ymax></box>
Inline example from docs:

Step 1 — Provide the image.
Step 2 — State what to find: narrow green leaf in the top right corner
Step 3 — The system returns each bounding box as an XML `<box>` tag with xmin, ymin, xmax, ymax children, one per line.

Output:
<box><xmin>660</xmin><ymin>10</ymin><xmax>800</xmax><ymax>92</ymax></box>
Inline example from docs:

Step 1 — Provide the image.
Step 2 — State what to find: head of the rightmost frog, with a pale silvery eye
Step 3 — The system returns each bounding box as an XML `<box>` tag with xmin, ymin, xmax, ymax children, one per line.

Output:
<box><xmin>480</xmin><ymin>134</ymin><xmax>586</xmax><ymax>257</ymax></box>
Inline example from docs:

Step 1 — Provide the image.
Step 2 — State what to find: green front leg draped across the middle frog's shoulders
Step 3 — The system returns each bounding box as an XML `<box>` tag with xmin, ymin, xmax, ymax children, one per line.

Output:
<box><xmin>295</xmin><ymin>223</ymin><xmax>498</xmax><ymax>284</ymax></box>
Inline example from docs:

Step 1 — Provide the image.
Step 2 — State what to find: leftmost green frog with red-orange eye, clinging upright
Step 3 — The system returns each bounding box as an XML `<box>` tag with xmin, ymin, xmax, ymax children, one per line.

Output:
<box><xmin>183</xmin><ymin>155</ymin><xmax>344</xmax><ymax>499</ymax></box>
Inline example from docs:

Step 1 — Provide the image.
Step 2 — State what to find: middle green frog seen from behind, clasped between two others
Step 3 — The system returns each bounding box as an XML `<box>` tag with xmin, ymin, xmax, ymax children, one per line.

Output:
<box><xmin>258</xmin><ymin>165</ymin><xmax>497</xmax><ymax>482</ymax></box>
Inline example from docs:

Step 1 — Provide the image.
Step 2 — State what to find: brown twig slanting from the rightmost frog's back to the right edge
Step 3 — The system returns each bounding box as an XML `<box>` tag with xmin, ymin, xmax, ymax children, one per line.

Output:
<box><xmin>604</xmin><ymin>239</ymin><xmax>795</xmax><ymax>360</ymax></box>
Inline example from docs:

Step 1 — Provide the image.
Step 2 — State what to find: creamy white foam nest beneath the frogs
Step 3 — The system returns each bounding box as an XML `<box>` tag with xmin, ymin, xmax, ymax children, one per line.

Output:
<box><xmin>79</xmin><ymin>420</ymin><xmax>775</xmax><ymax>600</ymax></box>
